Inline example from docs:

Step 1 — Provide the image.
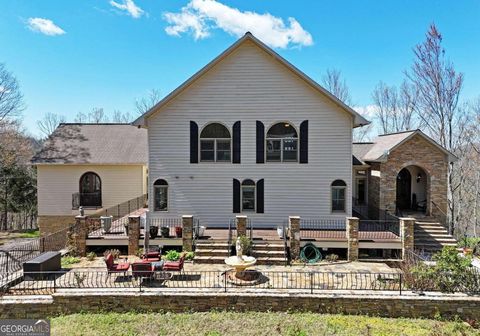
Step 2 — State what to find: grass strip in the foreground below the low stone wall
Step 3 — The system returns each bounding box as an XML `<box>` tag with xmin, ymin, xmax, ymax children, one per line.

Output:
<box><xmin>51</xmin><ymin>312</ymin><xmax>480</xmax><ymax>336</ymax></box>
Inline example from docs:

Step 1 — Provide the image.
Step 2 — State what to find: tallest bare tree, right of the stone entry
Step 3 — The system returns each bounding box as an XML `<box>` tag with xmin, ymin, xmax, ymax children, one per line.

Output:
<box><xmin>406</xmin><ymin>24</ymin><xmax>463</xmax><ymax>233</ymax></box>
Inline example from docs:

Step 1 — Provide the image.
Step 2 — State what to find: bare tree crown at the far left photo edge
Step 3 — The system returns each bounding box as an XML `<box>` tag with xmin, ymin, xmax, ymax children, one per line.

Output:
<box><xmin>0</xmin><ymin>63</ymin><xmax>25</xmax><ymax>122</ymax></box>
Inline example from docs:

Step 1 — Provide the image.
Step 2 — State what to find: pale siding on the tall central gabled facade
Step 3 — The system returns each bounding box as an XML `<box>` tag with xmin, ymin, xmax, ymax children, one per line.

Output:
<box><xmin>147</xmin><ymin>42</ymin><xmax>353</xmax><ymax>226</ymax></box>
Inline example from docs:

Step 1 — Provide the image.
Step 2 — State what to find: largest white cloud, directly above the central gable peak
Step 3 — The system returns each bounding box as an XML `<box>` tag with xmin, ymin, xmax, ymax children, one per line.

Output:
<box><xmin>164</xmin><ymin>0</ymin><xmax>313</xmax><ymax>48</ymax></box>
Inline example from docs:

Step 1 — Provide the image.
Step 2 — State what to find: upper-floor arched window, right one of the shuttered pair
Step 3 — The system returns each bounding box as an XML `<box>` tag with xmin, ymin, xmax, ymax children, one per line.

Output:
<box><xmin>266</xmin><ymin>122</ymin><xmax>298</xmax><ymax>162</ymax></box>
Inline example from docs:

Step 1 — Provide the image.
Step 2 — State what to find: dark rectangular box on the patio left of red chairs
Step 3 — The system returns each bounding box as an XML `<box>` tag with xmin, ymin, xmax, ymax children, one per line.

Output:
<box><xmin>23</xmin><ymin>251</ymin><xmax>62</xmax><ymax>280</ymax></box>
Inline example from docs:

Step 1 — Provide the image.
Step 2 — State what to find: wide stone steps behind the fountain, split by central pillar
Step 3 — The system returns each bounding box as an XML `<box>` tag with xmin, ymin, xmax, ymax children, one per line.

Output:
<box><xmin>193</xmin><ymin>240</ymin><xmax>285</xmax><ymax>265</ymax></box>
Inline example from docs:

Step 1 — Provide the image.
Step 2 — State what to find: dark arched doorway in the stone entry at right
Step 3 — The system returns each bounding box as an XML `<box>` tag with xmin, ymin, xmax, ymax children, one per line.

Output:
<box><xmin>396</xmin><ymin>165</ymin><xmax>428</xmax><ymax>213</ymax></box>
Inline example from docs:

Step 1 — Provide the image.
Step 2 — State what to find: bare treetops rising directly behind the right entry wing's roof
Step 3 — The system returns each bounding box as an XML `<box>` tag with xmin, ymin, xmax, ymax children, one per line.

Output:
<box><xmin>372</xmin><ymin>81</ymin><xmax>418</xmax><ymax>133</ymax></box>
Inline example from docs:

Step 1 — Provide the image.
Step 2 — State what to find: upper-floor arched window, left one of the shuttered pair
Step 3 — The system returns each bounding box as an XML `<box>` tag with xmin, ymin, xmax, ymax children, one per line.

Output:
<box><xmin>200</xmin><ymin>123</ymin><xmax>232</xmax><ymax>162</ymax></box>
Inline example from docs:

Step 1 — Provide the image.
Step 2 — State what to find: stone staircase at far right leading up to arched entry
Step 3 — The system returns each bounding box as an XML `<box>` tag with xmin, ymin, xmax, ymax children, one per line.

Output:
<box><xmin>414</xmin><ymin>219</ymin><xmax>457</xmax><ymax>253</ymax></box>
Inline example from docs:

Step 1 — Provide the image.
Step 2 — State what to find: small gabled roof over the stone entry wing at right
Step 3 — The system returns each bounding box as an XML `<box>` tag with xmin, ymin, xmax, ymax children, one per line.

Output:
<box><xmin>353</xmin><ymin>129</ymin><xmax>457</xmax><ymax>162</ymax></box>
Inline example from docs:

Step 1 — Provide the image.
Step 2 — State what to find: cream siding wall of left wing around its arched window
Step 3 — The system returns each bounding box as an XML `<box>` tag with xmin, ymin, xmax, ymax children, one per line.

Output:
<box><xmin>37</xmin><ymin>164</ymin><xmax>146</xmax><ymax>216</ymax></box>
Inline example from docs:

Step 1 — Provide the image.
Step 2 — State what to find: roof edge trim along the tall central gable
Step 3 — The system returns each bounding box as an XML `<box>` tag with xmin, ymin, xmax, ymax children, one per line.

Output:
<box><xmin>133</xmin><ymin>32</ymin><xmax>370</xmax><ymax>127</ymax></box>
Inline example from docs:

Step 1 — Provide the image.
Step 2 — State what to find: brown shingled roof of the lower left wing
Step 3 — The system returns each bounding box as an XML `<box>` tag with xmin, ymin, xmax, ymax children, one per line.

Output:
<box><xmin>32</xmin><ymin>123</ymin><xmax>148</xmax><ymax>165</ymax></box>
